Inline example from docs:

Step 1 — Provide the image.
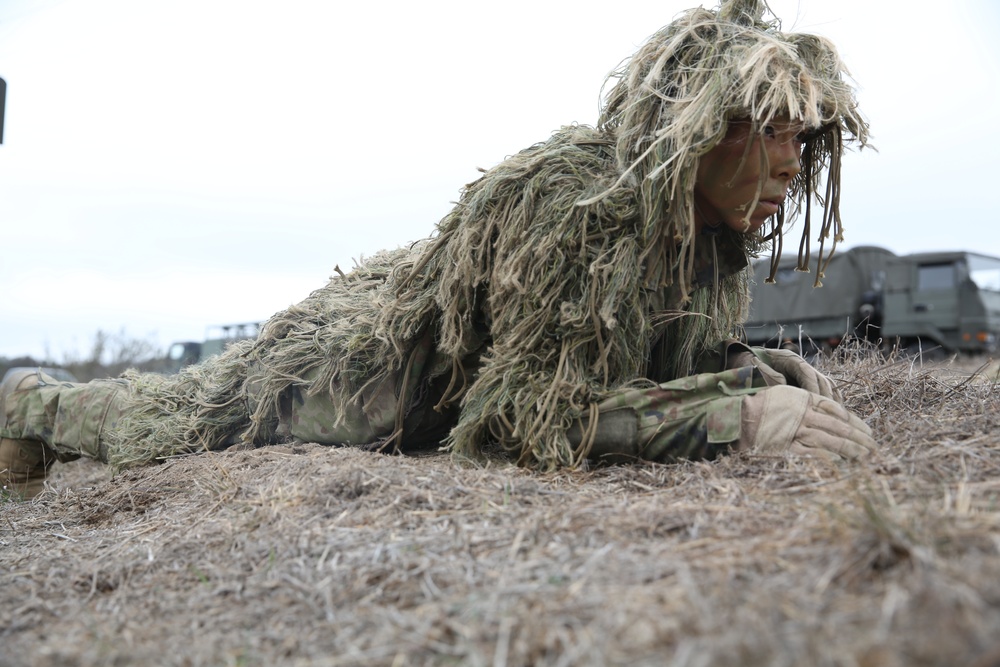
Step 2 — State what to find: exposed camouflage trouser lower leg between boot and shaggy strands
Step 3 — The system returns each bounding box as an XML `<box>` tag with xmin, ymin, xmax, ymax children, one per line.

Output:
<box><xmin>0</xmin><ymin>373</ymin><xmax>127</xmax><ymax>461</ymax></box>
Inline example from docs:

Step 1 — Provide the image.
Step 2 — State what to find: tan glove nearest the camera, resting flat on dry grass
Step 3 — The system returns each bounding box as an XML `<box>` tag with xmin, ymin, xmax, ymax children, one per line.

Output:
<box><xmin>739</xmin><ymin>385</ymin><xmax>876</xmax><ymax>460</ymax></box>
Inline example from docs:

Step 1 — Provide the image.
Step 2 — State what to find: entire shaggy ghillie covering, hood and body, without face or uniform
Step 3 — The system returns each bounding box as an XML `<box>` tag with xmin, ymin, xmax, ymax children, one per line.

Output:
<box><xmin>99</xmin><ymin>0</ymin><xmax>867</xmax><ymax>469</ymax></box>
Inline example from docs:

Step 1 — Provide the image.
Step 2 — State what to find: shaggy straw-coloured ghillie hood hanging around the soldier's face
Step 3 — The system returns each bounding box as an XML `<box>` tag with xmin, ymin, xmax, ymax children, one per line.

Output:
<box><xmin>598</xmin><ymin>0</ymin><xmax>868</xmax><ymax>292</ymax></box>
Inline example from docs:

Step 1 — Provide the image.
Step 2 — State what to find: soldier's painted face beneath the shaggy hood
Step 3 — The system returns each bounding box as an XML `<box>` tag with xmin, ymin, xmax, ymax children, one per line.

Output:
<box><xmin>694</xmin><ymin>121</ymin><xmax>804</xmax><ymax>232</ymax></box>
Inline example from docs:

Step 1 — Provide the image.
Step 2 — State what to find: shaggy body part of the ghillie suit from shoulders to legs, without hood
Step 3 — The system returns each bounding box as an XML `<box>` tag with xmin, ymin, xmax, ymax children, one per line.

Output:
<box><xmin>103</xmin><ymin>127</ymin><xmax>746</xmax><ymax>469</ymax></box>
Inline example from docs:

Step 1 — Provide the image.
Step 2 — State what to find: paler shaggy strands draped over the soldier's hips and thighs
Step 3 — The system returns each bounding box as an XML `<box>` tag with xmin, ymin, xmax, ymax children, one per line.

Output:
<box><xmin>108</xmin><ymin>246</ymin><xmax>419</xmax><ymax>468</ymax></box>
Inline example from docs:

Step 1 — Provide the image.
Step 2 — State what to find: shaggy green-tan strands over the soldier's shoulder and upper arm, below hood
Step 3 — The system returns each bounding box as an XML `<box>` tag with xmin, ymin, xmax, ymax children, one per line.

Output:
<box><xmin>382</xmin><ymin>126</ymin><xmax>756</xmax><ymax>469</ymax></box>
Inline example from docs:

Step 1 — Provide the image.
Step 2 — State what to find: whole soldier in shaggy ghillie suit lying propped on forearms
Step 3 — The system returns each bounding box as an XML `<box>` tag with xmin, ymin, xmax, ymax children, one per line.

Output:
<box><xmin>0</xmin><ymin>0</ymin><xmax>874</xmax><ymax>495</ymax></box>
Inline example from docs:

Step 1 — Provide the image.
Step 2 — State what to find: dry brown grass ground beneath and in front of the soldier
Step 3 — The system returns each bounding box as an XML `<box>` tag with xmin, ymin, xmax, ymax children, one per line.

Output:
<box><xmin>0</xmin><ymin>357</ymin><xmax>1000</xmax><ymax>667</ymax></box>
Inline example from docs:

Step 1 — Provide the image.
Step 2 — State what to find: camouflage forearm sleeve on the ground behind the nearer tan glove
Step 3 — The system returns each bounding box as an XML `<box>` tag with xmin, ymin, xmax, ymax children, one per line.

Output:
<box><xmin>569</xmin><ymin>367</ymin><xmax>766</xmax><ymax>462</ymax></box>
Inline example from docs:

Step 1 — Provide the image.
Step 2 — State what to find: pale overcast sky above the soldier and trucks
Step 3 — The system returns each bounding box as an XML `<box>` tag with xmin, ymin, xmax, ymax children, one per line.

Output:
<box><xmin>0</xmin><ymin>0</ymin><xmax>1000</xmax><ymax>361</ymax></box>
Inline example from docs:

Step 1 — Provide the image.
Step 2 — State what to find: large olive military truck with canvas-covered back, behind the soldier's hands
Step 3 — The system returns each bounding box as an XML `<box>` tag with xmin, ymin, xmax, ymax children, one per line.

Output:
<box><xmin>745</xmin><ymin>246</ymin><xmax>1000</xmax><ymax>354</ymax></box>
